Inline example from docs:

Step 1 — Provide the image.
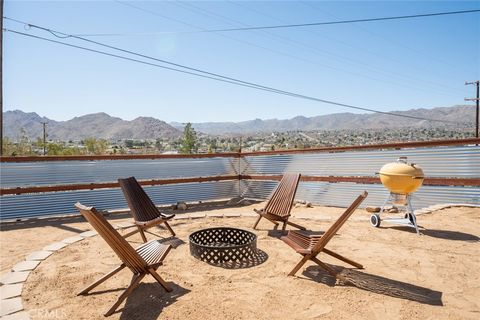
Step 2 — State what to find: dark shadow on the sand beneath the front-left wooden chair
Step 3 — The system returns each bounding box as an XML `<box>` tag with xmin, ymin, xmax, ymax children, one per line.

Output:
<box><xmin>115</xmin><ymin>282</ymin><xmax>190</xmax><ymax>320</ymax></box>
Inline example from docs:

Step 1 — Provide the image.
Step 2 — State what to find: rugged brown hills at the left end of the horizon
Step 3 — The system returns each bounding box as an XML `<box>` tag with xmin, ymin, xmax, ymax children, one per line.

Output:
<box><xmin>3</xmin><ymin>110</ymin><xmax>181</xmax><ymax>141</ymax></box>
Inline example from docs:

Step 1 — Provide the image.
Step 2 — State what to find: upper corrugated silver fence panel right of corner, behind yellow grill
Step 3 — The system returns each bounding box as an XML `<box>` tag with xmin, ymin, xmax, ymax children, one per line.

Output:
<box><xmin>244</xmin><ymin>146</ymin><xmax>480</xmax><ymax>178</ymax></box>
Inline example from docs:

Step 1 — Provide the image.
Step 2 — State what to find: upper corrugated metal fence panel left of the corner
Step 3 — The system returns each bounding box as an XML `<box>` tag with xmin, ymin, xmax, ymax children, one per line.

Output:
<box><xmin>0</xmin><ymin>157</ymin><xmax>239</xmax><ymax>188</ymax></box>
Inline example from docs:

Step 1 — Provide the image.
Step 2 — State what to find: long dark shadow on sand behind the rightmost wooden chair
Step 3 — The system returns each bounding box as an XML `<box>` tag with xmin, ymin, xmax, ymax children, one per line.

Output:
<box><xmin>303</xmin><ymin>266</ymin><xmax>443</xmax><ymax>306</ymax></box>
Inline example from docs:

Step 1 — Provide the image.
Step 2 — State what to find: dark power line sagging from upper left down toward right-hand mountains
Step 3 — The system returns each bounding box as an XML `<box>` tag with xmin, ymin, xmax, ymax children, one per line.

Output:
<box><xmin>3</xmin><ymin>25</ymin><xmax>462</xmax><ymax>124</ymax></box>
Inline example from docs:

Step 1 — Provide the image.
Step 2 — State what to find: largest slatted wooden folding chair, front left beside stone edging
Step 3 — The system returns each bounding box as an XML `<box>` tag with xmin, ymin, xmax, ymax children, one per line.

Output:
<box><xmin>75</xmin><ymin>202</ymin><xmax>172</xmax><ymax>317</ymax></box>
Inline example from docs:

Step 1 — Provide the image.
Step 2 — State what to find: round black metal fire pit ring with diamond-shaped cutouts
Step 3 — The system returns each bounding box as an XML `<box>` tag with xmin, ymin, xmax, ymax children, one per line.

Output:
<box><xmin>189</xmin><ymin>227</ymin><xmax>257</xmax><ymax>264</ymax></box>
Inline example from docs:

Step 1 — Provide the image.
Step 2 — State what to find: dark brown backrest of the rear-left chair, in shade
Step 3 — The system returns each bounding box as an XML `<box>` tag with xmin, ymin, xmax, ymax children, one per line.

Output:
<box><xmin>118</xmin><ymin>177</ymin><xmax>160</xmax><ymax>221</ymax></box>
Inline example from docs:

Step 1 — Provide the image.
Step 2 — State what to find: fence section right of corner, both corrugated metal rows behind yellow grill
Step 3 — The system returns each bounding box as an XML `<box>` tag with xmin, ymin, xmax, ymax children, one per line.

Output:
<box><xmin>240</xmin><ymin>145</ymin><xmax>480</xmax><ymax>208</ymax></box>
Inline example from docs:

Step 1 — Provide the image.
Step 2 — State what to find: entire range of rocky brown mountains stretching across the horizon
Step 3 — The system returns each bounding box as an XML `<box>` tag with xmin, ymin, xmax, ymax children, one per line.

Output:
<box><xmin>3</xmin><ymin>105</ymin><xmax>475</xmax><ymax>141</ymax></box>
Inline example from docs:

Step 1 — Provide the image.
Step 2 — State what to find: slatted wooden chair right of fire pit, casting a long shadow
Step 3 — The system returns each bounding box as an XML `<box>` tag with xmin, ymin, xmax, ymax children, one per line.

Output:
<box><xmin>281</xmin><ymin>191</ymin><xmax>368</xmax><ymax>277</ymax></box>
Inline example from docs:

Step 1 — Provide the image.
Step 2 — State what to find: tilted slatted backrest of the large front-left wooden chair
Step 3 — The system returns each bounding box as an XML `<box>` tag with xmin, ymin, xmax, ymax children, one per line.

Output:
<box><xmin>75</xmin><ymin>202</ymin><xmax>147</xmax><ymax>274</ymax></box>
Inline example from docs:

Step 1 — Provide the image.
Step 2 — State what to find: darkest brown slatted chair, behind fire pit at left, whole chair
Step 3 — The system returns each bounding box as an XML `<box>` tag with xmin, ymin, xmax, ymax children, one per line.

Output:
<box><xmin>118</xmin><ymin>177</ymin><xmax>175</xmax><ymax>242</ymax></box>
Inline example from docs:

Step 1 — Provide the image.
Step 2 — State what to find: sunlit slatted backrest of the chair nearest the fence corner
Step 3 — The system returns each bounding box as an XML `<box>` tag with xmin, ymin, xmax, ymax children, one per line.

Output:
<box><xmin>264</xmin><ymin>173</ymin><xmax>301</xmax><ymax>217</ymax></box>
